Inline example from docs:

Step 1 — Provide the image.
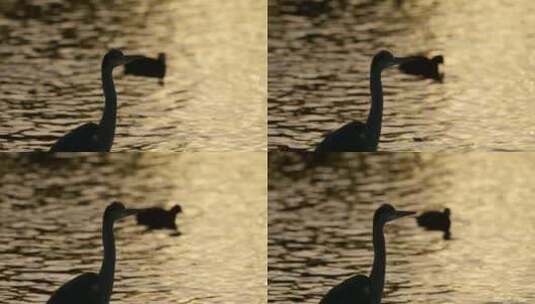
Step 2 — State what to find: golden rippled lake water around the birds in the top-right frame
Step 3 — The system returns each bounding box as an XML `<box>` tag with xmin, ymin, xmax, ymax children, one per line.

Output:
<box><xmin>268</xmin><ymin>0</ymin><xmax>535</xmax><ymax>151</ymax></box>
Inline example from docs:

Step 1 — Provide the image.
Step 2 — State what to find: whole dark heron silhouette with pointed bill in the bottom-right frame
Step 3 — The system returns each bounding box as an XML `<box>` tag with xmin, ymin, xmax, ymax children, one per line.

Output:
<box><xmin>320</xmin><ymin>204</ymin><xmax>415</xmax><ymax>304</ymax></box>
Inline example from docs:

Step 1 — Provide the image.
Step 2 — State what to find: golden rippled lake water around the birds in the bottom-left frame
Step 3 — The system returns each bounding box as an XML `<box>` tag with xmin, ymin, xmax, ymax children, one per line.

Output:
<box><xmin>0</xmin><ymin>153</ymin><xmax>267</xmax><ymax>304</ymax></box>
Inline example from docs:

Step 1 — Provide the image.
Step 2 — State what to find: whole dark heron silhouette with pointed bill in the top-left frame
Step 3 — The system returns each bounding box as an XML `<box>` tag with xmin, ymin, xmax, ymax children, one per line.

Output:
<box><xmin>50</xmin><ymin>49</ymin><xmax>140</xmax><ymax>152</ymax></box>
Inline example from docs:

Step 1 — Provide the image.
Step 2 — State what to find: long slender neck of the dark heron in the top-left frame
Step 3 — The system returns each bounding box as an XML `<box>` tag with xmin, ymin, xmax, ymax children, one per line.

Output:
<box><xmin>98</xmin><ymin>65</ymin><xmax>117</xmax><ymax>151</ymax></box>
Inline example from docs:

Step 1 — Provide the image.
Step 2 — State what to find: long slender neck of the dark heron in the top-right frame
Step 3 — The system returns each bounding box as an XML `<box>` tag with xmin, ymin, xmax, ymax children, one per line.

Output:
<box><xmin>366</xmin><ymin>66</ymin><xmax>383</xmax><ymax>142</ymax></box>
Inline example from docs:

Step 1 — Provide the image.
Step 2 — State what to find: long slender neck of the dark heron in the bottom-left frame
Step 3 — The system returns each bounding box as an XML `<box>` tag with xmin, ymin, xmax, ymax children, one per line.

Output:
<box><xmin>99</xmin><ymin>220</ymin><xmax>115</xmax><ymax>303</ymax></box>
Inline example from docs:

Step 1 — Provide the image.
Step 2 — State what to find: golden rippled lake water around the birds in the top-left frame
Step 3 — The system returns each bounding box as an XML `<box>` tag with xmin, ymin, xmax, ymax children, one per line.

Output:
<box><xmin>0</xmin><ymin>0</ymin><xmax>267</xmax><ymax>151</ymax></box>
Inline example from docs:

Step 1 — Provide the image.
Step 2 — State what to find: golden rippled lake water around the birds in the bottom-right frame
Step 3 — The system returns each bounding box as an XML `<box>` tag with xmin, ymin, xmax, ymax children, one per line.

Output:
<box><xmin>268</xmin><ymin>153</ymin><xmax>535</xmax><ymax>304</ymax></box>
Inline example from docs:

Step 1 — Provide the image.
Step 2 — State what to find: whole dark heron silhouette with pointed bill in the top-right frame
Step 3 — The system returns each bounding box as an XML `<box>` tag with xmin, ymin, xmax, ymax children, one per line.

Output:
<box><xmin>315</xmin><ymin>50</ymin><xmax>418</xmax><ymax>153</ymax></box>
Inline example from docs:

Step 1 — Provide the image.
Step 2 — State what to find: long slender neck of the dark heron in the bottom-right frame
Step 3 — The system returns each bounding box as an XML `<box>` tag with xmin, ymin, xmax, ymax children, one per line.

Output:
<box><xmin>370</xmin><ymin>220</ymin><xmax>386</xmax><ymax>303</ymax></box>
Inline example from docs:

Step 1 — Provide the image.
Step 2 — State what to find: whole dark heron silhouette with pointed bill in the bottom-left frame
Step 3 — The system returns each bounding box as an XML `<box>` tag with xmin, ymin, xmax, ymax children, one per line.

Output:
<box><xmin>46</xmin><ymin>202</ymin><xmax>137</xmax><ymax>304</ymax></box>
